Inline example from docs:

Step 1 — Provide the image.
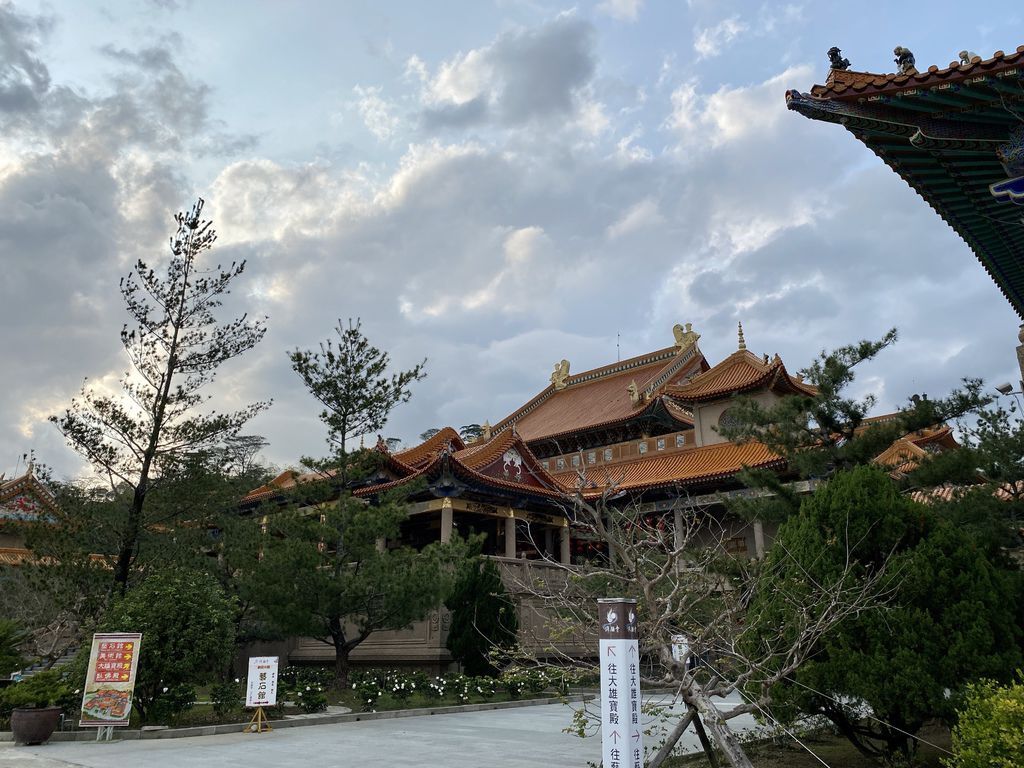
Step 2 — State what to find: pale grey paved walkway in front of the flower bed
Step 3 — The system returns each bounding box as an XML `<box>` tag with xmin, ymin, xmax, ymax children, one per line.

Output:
<box><xmin>0</xmin><ymin>703</ymin><xmax>752</xmax><ymax>768</ymax></box>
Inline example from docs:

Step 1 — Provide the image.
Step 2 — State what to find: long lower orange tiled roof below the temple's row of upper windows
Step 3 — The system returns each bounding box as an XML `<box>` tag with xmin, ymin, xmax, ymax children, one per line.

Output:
<box><xmin>554</xmin><ymin>442</ymin><xmax>784</xmax><ymax>496</ymax></box>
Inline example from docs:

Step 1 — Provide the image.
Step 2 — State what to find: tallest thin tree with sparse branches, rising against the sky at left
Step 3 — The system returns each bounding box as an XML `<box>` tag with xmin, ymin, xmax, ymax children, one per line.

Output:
<box><xmin>50</xmin><ymin>199</ymin><xmax>269</xmax><ymax>592</ymax></box>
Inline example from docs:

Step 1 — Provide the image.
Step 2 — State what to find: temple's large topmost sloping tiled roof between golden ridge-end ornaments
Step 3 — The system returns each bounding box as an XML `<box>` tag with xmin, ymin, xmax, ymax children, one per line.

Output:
<box><xmin>494</xmin><ymin>343</ymin><xmax>708</xmax><ymax>442</ymax></box>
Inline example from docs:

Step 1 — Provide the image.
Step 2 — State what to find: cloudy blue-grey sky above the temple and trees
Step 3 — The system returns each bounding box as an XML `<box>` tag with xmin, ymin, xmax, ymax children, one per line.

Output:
<box><xmin>0</xmin><ymin>0</ymin><xmax>1024</xmax><ymax>481</ymax></box>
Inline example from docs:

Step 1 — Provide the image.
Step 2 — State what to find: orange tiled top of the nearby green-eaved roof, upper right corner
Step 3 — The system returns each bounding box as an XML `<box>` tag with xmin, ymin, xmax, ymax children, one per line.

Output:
<box><xmin>811</xmin><ymin>45</ymin><xmax>1024</xmax><ymax>101</ymax></box>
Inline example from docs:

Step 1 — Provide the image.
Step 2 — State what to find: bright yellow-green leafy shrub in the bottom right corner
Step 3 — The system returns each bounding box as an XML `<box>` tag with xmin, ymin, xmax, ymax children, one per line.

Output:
<box><xmin>945</xmin><ymin>673</ymin><xmax>1024</xmax><ymax>768</ymax></box>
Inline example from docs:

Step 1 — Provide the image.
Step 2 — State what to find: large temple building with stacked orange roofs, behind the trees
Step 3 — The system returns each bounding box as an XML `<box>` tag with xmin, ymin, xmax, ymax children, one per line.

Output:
<box><xmin>243</xmin><ymin>324</ymin><xmax>856</xmax><ymax>668</ymax></box>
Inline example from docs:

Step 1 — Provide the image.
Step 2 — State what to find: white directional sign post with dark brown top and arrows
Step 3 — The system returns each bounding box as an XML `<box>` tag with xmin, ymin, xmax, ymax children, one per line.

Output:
<box><xmin>597</xmin><ymin>598</ymin><xmax>643</xmax><ymax>768</ymax></box>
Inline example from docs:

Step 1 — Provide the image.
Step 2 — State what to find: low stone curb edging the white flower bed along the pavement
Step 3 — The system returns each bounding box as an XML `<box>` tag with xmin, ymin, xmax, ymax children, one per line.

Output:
<box><xmin>0</xmin><ymin>693</ymin><xmax>593</xmax><ymax>742</ymax></box>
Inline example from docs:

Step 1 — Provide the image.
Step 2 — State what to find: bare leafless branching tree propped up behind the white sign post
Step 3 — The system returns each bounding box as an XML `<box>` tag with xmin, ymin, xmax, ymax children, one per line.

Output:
<box><xmin>503</xmin><ymin>478</ymin><xmax>893</xmax><ymax>768</ymax></box>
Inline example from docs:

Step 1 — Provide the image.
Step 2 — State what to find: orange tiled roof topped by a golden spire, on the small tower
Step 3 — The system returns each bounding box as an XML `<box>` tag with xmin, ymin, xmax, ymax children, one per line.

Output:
<box><xmin>666</xmin><ymin>349</ymin><xmax>816</xmax><ymax>403</ymax></box>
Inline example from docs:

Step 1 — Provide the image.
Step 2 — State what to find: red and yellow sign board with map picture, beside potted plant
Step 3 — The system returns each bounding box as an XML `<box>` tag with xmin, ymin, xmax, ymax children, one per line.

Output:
<box><xmin>79</xmin><ymin>632</ymin><xmax>142</xmax><ymax>726</ymax></box>
